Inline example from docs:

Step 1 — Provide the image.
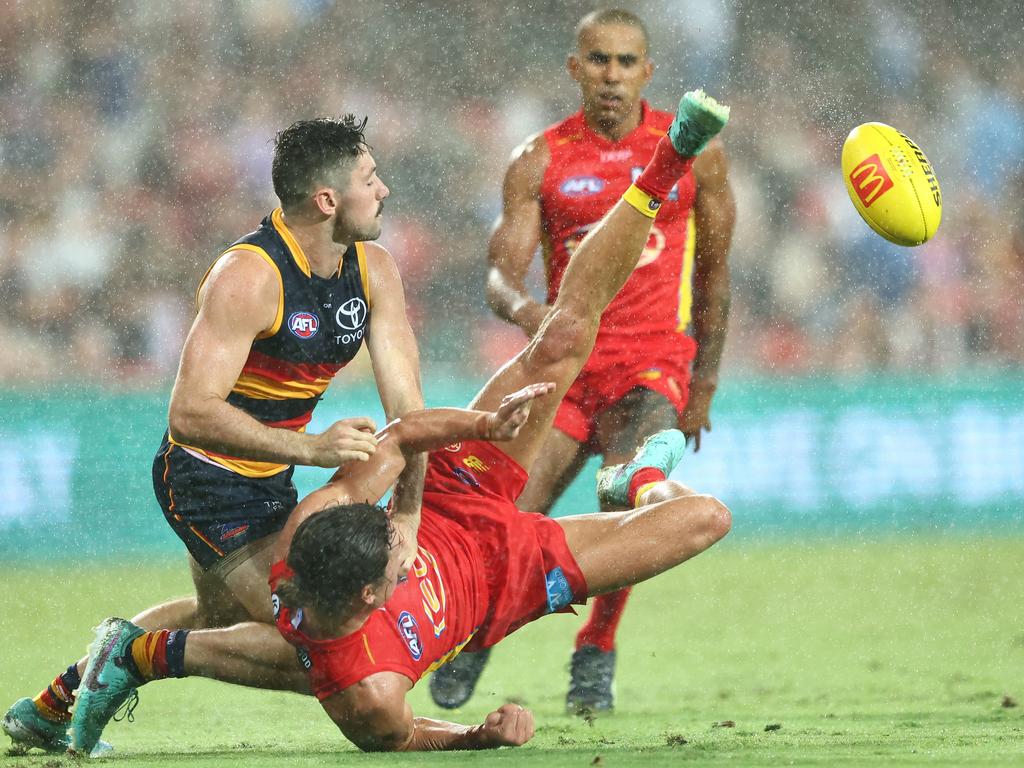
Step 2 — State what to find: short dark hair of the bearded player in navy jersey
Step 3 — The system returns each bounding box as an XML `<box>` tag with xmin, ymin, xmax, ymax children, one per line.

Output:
<box><xmin>270</xmin><ymin>115</ymin><xmax>370</xmax><ymax>208</ymax></box>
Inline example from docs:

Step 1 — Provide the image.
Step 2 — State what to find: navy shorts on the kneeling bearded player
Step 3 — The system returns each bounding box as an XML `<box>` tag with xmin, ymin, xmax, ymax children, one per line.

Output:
<box><xmin>153</xmin><ymin>435</ymin><xmax>298</xmax><ymax>569</ymax></box>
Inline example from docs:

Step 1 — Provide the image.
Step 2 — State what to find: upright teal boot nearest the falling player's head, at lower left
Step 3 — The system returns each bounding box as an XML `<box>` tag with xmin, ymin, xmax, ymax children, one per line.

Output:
<box><xmin>68</xmin><ymin>618</ymin><xmax>143</xmax><ymax>755</ymax></box>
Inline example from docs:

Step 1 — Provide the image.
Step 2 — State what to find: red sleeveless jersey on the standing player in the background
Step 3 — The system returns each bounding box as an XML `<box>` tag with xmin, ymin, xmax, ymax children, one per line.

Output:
<box><xmin>540</xmin><ymin>101</ymin><xmax>696</xmax><ymax>351</ymax></box>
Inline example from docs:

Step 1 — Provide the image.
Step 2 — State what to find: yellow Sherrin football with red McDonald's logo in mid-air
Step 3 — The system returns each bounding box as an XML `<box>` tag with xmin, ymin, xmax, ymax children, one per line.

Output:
<box><xmin>843</xmin><ymin>123</ymin><xmax>942</xmax><ymax>246</ymax></box>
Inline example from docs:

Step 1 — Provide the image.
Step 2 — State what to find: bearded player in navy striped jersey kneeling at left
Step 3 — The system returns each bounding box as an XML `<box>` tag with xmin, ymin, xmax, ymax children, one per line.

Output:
<box><xmin>3</xmin><ymin>115</ymin><xmax>423</xmax><ymax>752</ymax></box>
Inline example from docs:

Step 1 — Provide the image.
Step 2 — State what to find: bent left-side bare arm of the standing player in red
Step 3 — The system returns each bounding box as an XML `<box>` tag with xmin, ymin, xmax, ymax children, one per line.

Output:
<box><xmin>486</xmin><ymin>135</ymin><xmax>551</xmax><ymax>337</ymax></box>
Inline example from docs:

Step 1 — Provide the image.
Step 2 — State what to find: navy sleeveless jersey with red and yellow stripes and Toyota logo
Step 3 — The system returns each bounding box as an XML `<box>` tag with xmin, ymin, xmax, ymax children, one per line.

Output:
<box><xmin>169</xmin><ymin>208</ymin><xmax>371</xmax><ymax>477</ymax></box>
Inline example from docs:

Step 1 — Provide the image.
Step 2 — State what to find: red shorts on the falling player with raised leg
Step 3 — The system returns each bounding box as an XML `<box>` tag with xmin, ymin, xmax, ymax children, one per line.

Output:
<box><xmin>423</xmin><ymin>440</ymin><xmax>587</xmax><ymax>650</ymax></box>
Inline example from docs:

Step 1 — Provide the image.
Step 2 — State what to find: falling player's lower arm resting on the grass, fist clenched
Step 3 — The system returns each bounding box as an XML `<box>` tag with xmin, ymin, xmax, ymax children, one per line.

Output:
<box><xmin>321</xmin><ymin>672</ymin><xmax>534</xmax><ymax>752</ymax></box>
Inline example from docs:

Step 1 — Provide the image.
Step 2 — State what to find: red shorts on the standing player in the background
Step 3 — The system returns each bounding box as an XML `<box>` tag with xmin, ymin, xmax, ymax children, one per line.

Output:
<box><xmin>555</xmin><ymin>334</ymin><xmax>697</xmax><ymax>443</ymax></box>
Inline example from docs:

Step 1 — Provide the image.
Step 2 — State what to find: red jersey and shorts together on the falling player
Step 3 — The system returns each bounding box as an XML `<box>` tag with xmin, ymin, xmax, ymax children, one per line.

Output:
<box><xmin>270</xmin><ymin>440</ymin><xmax>588</xmax><ymax>700</ymax></box>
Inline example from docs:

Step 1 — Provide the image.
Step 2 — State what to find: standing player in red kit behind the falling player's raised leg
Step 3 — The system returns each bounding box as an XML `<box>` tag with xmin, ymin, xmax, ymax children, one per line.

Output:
<box><xmin>430</xmin><ymin>10</ymin><xmax>735</xmax><ymax>714</ymax></box>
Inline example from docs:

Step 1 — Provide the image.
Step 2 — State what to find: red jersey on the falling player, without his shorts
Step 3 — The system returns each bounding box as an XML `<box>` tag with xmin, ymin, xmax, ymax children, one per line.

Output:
<box><xmin>270</xmin><ymin>511</ymin><xmax>488</xmax><ymax>700</ymax></box>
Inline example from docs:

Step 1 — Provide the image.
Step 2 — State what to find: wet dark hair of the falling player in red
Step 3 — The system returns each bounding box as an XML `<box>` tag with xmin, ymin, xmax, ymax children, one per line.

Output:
<box><xmin>276</xmin><ymin>503</ymin><xmax>394</xmax><ymax>616</ymax></box>
